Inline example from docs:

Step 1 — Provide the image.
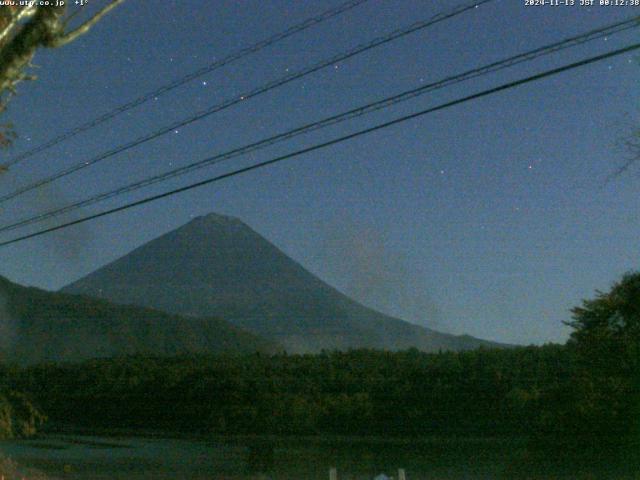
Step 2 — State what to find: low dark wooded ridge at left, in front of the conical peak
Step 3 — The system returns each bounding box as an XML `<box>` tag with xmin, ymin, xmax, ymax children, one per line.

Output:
<box><xmin>0</xmin><ymin>277</ymin><xmax>275</xmax><ymax>363</ymax></box>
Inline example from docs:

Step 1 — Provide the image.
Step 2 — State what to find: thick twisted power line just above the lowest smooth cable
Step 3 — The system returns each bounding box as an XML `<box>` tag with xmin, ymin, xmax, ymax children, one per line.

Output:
<box><xmin>0</xmin><ymin>16</ymin><xmax>640</xmax><ymax>236</ymax></box>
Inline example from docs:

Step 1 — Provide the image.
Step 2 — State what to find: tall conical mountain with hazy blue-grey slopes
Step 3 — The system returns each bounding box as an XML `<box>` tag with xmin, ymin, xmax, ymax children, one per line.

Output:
<box><xmin>63</xmin><ymin>214</ymin><xmax>498</xmax><ymax>352</ymax></box>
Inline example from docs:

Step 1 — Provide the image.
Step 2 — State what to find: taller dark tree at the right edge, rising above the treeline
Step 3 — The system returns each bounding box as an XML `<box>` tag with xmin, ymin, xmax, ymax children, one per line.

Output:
<box><xmin>567</xmin><ymin>272</ymin><xmax>640</xmax><ymax>462</ymax></box>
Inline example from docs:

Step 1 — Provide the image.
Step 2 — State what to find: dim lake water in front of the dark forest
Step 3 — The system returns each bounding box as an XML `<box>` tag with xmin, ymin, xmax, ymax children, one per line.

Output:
<box><xmin>0</xmin><ymin>435</ymin><xmax>632</xmax><ymax>480</ymax></box>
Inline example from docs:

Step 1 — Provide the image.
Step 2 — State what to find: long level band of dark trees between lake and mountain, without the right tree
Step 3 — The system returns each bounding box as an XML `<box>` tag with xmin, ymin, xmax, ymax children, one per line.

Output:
<box><xmin>5</xmin><ymin>346</ymin><xmax>573</xmax><ymax>436</ymax></box>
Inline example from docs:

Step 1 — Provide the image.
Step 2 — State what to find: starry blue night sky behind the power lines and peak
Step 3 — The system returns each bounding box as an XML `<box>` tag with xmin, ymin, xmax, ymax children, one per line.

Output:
<box><xmin>0</xmin><ymin>0</ymin><xmax>640</xmax><ymax>344</ymax></box>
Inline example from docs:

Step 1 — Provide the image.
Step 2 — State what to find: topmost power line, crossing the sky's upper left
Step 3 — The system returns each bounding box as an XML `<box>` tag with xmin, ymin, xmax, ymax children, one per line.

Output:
<box><xmin>3</xmin><ymin>0</ymin><xmax>369</xmax><ymax>168</ymax></box>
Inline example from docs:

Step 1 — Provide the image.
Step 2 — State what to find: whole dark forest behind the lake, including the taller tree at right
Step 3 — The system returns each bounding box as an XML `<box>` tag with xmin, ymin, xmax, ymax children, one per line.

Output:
<box><xmin>0</xmin><ymin>274</ymin><xmax>640</xmax><ymax>472</ymax></box>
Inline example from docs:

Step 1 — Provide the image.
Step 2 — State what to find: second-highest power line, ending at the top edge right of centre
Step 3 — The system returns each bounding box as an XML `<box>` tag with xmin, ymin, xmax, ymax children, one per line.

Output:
<box><xmin>0</xmin><ymin>0</ymin><xmax>495</xmax><ymax>203</ymax></box>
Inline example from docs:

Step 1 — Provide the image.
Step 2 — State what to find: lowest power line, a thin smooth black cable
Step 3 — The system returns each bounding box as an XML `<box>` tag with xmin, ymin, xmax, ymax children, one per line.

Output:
<box><xmin>0</xmin><ymin>43</ymin><xmax>640</xmax><ymax>247</ymax></box>
